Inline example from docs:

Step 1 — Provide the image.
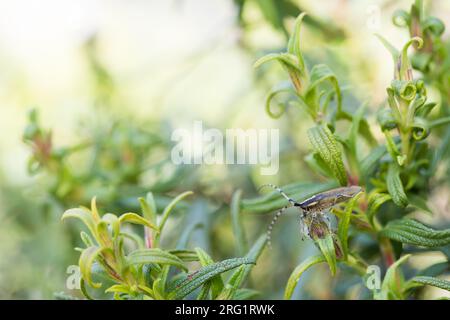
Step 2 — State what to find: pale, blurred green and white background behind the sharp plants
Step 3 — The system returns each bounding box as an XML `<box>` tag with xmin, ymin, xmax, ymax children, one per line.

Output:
<box><xmin>0</xmin><ymin>0</ymin><xmax>450</xmax><ymax>299</ymax></box>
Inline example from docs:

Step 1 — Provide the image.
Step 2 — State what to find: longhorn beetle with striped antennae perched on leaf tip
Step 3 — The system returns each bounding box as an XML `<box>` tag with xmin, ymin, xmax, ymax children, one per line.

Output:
<box><xmin>258</xmin><ymin>184</ymin><xmax>362</xmax><ymax>247</ymax></box>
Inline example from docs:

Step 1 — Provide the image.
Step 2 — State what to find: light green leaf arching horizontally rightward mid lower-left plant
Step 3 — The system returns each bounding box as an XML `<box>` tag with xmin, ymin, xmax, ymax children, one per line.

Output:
<box><xmin>127</xmin><ymin>248</ymin><xmax>187</xmax><ymax>271</ymax></box>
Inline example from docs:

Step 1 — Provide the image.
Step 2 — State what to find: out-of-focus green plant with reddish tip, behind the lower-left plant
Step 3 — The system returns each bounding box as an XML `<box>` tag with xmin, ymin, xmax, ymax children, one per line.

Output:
<box><xmin>23</xmin><ymin>109</ymin><xmax>193</xmax><ymax>210</ymax></box>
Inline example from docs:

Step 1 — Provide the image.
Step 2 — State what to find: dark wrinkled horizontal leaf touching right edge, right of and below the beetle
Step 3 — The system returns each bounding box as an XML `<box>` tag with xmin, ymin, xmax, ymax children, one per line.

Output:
<box><xmin>380</xmin><ymin>218</ymin><xmax>450</xmax><ymax>248</ymax></box>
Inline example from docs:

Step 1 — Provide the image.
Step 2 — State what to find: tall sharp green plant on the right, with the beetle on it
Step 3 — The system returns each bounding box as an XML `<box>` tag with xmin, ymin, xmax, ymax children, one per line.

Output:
<box><xmin>251</xmin><ymin>7</ymin><xmax>450</xmax><ymax>299</ymax></box>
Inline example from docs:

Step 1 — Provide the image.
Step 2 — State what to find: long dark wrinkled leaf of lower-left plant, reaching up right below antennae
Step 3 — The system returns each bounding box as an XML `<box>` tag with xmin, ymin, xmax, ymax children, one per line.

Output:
<box><xmin>169</xmin><ymin>258</ymin><xmax>254</xmax><ymax>300</ymax></box>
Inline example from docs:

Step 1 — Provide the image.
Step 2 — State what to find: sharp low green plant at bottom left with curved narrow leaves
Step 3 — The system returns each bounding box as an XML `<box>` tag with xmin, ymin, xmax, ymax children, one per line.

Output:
<box><xmin>63</xmin><ymin>191</ymin><xmax>265</xmax><ymax>299</ymax></box>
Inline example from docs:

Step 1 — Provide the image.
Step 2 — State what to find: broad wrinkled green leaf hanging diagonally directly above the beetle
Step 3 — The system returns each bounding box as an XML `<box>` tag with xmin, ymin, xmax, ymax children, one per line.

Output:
<box><xmin>308</xmin><ymin>125</ymin><xmax>347</xmax><ymax>186</ymax></box>
